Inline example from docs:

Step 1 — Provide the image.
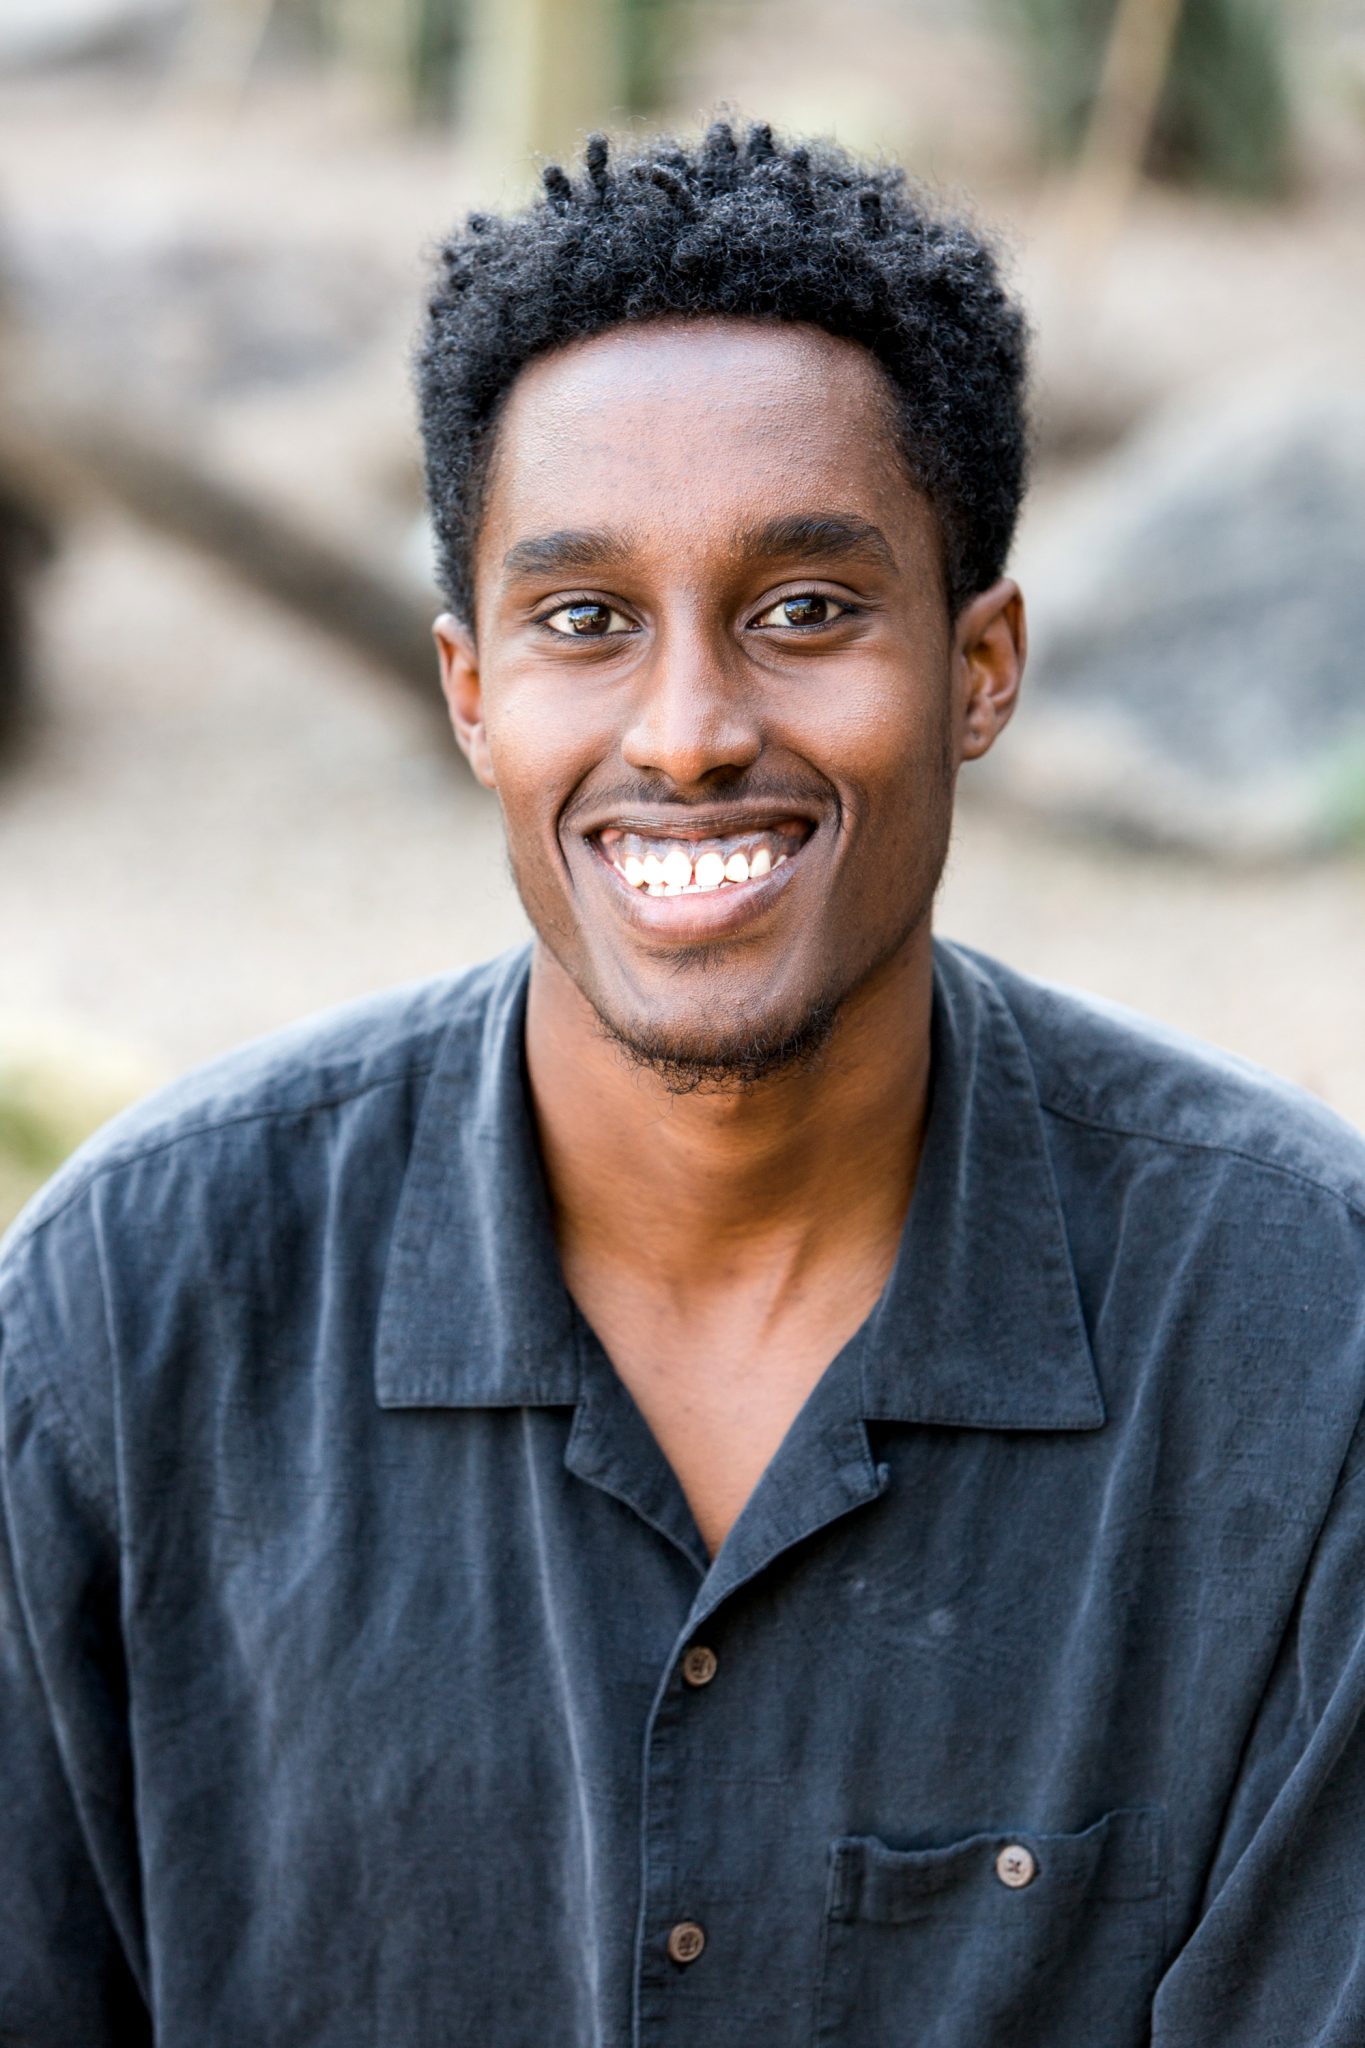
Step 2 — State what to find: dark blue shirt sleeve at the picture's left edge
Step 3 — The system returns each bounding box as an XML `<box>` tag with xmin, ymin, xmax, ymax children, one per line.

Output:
<box><xmin>0</xmin><ymin>1253</ymin><xmax>151</xmax><ymax>2048</ymax></box>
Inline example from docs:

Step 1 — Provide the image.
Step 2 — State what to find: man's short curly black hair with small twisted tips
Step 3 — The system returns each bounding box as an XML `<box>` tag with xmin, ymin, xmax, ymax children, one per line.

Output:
<box><xmin>417</xmin><ymin>121</ymin><xmax>1027</xmax><ymax>625</ymax></box>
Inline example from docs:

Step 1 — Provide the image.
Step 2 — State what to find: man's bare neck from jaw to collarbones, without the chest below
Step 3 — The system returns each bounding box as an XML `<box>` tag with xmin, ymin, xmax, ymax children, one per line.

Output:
<box><xmin>526</xmin><ymin>926</ymin><xmax>933</xmax><ymax>1298</ymax></box>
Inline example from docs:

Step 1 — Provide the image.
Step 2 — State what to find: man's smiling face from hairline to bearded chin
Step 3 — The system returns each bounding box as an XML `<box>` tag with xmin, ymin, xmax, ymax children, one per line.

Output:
<box><xmin>442</xmin><ymin>319</ymin><xmax>1017</xmax><ymax>1081</ymax></box>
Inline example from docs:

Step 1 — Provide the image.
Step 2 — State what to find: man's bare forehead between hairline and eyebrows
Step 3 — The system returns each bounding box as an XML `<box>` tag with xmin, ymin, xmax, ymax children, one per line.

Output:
<box><xmin>485</xmin><ymin>317</ymin><xmax>919</xmax><ymax>547</ymax></box>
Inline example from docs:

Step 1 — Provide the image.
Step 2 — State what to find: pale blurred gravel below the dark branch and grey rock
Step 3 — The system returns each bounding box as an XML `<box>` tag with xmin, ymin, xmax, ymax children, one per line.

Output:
<box><xmin>0</xmin><ymin>522</ymin><xmax>1365</xmax><ymax>1124</ymax></box>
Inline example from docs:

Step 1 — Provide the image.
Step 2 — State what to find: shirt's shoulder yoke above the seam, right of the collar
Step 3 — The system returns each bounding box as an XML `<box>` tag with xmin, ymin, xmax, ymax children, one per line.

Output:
<box><xmin>945</xmin><ymin>946</ymin><xmax>1365</xmax><ymax>1223</ymax></box>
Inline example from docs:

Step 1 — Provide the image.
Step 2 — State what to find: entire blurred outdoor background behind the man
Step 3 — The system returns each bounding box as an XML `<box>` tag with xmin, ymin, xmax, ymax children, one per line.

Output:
<box><xmin>0</xmin><ymin>0</ymin><xmax>1365</xmax><ymax>1219</ymax></box>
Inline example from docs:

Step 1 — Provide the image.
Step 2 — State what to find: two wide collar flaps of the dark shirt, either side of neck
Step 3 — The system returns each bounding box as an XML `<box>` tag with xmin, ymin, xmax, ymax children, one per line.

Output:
<box><xmin>377</xmin><ymin>942</ymin><xmax>1105</xmax><ymax>1430</ymax></box>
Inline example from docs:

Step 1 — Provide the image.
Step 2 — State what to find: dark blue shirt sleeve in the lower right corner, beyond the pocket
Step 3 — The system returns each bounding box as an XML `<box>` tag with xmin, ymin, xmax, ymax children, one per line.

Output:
<box><xmin>1152</xmin><ymin>1464</ymin><xmax>1365</xmax><ymax>2048</ymax></box>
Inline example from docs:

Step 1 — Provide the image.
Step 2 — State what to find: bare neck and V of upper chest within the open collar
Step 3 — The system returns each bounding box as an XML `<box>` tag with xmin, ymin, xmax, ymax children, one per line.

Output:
<box><xmin>526</xmin><ymin>932</ymin><xmax>933</xmax><ymax>1554</ymax></box>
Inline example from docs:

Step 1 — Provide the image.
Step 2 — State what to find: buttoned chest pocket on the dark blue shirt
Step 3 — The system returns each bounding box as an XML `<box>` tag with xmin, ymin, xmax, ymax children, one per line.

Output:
<box><xmin>814</xmin><ymin>1806</ymin><xmax>1164</xmax><ymax>2048</ymax></box>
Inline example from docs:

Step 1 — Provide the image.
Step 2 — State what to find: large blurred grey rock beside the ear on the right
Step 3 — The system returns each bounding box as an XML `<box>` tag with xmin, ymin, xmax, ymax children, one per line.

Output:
<box><xmin>986</xmin><ymin>381</ymin><xmax>1365</xmax><ymax>858</ymax></box>
